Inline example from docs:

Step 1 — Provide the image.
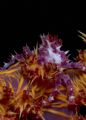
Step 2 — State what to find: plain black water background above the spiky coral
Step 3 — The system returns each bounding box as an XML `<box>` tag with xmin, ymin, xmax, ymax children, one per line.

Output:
<box><xmin>0</xmin><ymin>0</ymin><xmax>86</xmax><ymax>65</ymax></box>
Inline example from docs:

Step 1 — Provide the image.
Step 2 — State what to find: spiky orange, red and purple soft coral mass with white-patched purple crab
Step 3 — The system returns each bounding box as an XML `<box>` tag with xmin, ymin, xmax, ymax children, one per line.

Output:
<box><xmin>0</xmin><ymin>32</ymin><xmax>86</xmax><ymax>120</ymax></box>
